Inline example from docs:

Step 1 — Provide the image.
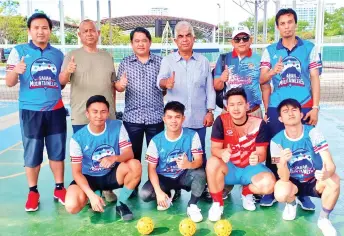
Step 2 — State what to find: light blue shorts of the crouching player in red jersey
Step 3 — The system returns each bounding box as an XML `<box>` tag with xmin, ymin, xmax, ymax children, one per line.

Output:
<box><xmin>225</xmin><ymin>162</ymin><xmax>272</xmax><ymax>185</ymax></box>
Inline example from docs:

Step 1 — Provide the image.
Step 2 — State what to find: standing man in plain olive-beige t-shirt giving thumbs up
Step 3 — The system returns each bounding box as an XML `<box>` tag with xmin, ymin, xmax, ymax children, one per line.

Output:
<box><xmin>60</xmin><ymin>20</ymin><xmax>116</xmax><ymax>202</ymax></box>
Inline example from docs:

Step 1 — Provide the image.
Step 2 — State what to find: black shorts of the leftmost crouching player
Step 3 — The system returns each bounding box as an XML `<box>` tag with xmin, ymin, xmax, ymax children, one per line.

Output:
<box><xmin>70</xmin><ymin>163</ymin><xmax>123</xmax><ymax>191</ymax></box>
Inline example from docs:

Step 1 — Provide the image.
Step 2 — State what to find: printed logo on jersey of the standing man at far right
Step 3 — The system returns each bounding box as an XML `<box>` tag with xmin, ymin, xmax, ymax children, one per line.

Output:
<box><xmin>278</xmin><ymin>56</ymin><xmax>305</xmax><ymax>88</ymax></box>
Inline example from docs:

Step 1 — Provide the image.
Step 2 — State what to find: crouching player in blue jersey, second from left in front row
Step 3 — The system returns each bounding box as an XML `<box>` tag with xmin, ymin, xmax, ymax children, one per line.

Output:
<box><xmin>140</xmin><ymin>101</ymin><xmax>206</xmax><ymax>222</ymax></box>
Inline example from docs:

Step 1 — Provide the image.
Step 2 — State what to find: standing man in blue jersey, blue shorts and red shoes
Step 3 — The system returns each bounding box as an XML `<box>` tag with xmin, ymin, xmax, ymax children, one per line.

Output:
<box><xmin>6</xmin><ymin>13</ymin><xmax>66</xmax><ymax>211</ymax></box>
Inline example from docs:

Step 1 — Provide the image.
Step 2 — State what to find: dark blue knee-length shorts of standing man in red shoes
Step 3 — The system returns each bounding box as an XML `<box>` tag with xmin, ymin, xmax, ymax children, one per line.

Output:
<box><xmin>19</xmin><ymin>107</ymin><xmax>67</xmax><ymax>168</ymax></box>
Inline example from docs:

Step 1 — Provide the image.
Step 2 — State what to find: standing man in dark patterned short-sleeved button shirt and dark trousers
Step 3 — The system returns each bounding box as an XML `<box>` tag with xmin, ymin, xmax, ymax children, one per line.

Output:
<box><xmin>116</xmin><ymin>27</ymin><xmax>164</xmax><ymax>179</ymax></box>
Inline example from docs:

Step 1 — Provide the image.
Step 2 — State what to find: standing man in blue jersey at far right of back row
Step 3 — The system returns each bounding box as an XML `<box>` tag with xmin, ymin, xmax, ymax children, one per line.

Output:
<box><xmin>260</xmin><ymin>8</ymin><xmax>321</xmax><ymax>210</ymax></box>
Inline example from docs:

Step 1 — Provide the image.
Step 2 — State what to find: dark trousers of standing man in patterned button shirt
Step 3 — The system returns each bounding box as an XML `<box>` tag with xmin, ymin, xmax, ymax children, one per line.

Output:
<box><xmin>123</xmin><ymin>121</ymin><xmax>164</xmax><ymax>162</ymax></box>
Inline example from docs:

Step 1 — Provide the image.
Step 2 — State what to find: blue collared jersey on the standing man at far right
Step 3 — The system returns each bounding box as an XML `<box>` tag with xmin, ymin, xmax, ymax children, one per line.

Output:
<box><xmin>261</xmin><ymin>37</ymin><xmax>321</xmax><ymax>107</ymax></box>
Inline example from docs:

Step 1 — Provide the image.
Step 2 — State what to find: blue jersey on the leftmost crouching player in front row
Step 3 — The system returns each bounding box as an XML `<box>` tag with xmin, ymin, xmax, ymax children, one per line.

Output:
<box><xmin>70</xmin><ymin>120</ymin><xmax>131</xmax><ymax>176</ymax></box>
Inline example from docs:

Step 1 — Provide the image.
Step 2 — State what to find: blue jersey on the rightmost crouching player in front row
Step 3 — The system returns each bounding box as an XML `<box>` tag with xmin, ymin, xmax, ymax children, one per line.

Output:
<box><xmin>270</xmin><ymin>125</ymin><xmax>328</xmax><ymax>182</ymax></box>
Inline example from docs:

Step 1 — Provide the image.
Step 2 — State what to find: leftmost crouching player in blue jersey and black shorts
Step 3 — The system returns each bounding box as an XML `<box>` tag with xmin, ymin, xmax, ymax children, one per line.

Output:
<box><xmin>66</xmin><ymin>95</ymin><xmax>141</xmax><ymax>220</ymax></box>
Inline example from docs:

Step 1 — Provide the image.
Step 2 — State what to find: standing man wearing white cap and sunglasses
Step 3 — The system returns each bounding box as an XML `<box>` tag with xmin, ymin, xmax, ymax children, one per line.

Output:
<box><xmin>214</xmin><ymin>26</ymin><xmax>268</xmax><ymax>118</ymax></box>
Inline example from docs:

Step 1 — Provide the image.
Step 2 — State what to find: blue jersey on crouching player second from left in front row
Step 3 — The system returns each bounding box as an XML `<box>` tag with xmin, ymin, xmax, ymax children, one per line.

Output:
<box><xmin>146</xmin><ymin>128</ymin><xmax>203</xmax><ymax>178</ymax></box>
